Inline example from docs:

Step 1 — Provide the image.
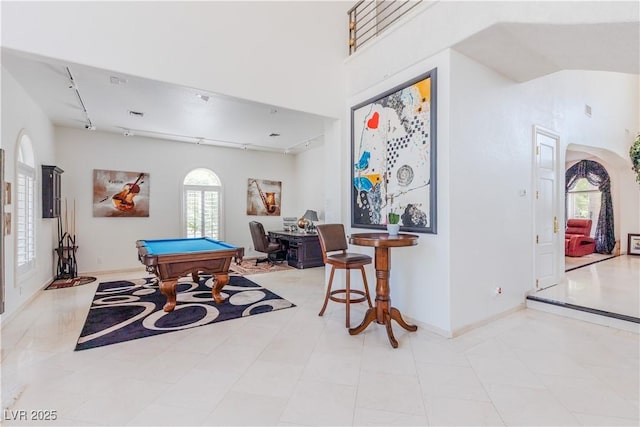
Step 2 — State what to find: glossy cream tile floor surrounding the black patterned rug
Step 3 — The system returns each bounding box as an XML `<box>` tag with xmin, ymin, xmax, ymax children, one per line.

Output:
<box><xmin>1</xmin><ymin>263</ymin><xmax>640</xmax><ymax>426</ymax></box>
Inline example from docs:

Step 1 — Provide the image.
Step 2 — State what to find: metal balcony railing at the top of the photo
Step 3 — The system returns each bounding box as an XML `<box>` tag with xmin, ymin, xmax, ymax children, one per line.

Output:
<box><xmin>347</xmin><ymin>0</ymin><xmax>422</xmax><ymax>55</ymax></box>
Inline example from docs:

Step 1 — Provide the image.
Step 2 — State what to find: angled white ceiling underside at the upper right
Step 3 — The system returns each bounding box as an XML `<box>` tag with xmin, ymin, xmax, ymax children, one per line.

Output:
<box><xmin>453</xmin><ymin>17</ymin><xmax>640</xmax><ymax>82</ymax></box>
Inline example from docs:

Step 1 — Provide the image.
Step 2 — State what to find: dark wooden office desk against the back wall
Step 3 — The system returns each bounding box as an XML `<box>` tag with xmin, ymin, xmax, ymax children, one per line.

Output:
<box><xmin>269</xmin><ymin>230</ymin><xmax>324</xmax><ymax>268</ymax></box>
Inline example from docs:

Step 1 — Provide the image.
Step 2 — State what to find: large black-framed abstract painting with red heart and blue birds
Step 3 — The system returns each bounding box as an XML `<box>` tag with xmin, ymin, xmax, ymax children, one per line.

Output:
<box><xmin>351</xmin><ymin>69</ymin><xmax>436</xmax><ymax>234</ymax></box>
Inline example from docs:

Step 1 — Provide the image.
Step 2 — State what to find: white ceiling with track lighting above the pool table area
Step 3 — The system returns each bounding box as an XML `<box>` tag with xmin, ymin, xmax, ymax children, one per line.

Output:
<box><xmin>2</xmin><ymin>48</ymin><xmax>324</xmax><ymax>153</ymax></box>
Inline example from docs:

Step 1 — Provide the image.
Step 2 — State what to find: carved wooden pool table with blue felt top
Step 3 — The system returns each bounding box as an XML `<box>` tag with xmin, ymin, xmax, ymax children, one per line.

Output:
<box><xmin>136</xmin><ymin>237</ymin><xmax>244</xmax><ymax>312</ymax></box>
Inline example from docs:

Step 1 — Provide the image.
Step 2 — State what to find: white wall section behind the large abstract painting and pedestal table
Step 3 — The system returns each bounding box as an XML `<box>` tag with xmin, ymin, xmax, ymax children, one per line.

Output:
<box><xmin>342</xmin><ymin>50</ymin><xmax>453</xmax><ymax>335</ymax></box>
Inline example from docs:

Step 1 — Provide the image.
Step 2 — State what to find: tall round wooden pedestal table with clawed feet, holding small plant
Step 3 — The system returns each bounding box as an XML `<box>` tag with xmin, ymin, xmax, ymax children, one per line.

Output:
<box><xmin>349</xmin><ymin>233</ymin><xmax>418</xmax><ymax>348</ymax></box>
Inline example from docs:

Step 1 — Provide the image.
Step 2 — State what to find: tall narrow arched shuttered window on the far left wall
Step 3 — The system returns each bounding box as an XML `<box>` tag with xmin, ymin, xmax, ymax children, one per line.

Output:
<box><xmin>15</xmin><ymin>133</ymin><xmax>36</xmax><ymax>274</ymax></box>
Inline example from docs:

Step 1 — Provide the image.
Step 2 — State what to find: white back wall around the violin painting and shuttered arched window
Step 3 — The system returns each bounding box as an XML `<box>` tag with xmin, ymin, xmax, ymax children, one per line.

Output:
<box><xmin>55</xmin><ymin>127</ymin><xmax>306</xmax><ymax>272</ymax></box>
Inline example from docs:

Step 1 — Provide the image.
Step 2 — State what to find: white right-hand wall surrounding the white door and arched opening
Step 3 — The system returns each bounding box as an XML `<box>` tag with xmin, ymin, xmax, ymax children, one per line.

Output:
<box><xmin>450</xmin><ymin>52</ymin><xmax>640</xmax><ymax>330</ymax></box>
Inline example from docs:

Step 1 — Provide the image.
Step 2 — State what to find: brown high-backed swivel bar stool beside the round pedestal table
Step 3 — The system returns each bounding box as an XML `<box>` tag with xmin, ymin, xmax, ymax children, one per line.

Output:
<box><xmin>317</xmin><ymin>224</ymin><xmax>373</xmax><ymax>328</ymax></box>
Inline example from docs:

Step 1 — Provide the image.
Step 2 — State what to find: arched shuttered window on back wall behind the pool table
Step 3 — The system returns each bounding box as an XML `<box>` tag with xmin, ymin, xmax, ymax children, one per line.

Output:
<box><xmin>182</xmin><ymin>168</ymin><xmax>222</xmax><ymax>240</ymax></box>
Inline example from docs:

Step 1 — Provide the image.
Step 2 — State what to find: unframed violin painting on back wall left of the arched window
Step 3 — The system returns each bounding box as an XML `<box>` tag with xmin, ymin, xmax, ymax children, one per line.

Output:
<box><xmin>93</xmin><ymin>169</ymin><xmax>150</xmax><ymax>217</ymax></box>
